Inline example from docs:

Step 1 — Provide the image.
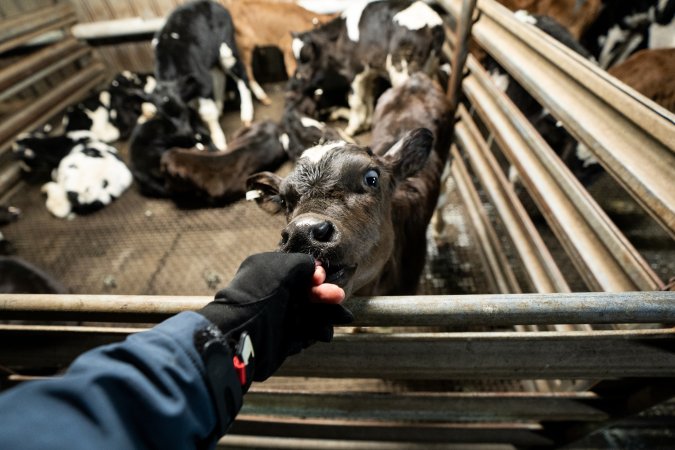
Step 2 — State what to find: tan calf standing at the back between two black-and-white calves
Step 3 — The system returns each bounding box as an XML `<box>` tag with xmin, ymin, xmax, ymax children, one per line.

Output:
<box><xmin>220</xmin><ymin>0</ymin><xmax>335</xmax><ymax>105</ymax></box>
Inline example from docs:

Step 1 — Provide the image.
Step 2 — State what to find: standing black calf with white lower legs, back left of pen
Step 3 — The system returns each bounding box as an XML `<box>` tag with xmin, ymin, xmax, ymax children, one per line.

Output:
<box><xmin>153</xmin><ymin>0</ymin><xmax>253</xmax><ymax>150</ymax></box>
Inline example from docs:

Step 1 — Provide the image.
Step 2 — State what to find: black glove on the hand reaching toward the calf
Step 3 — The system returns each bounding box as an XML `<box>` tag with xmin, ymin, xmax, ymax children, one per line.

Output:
<box><xmin>198</xmin><ymin>253</ymin><xmax>353</xmax><ymax>388</ymax></box>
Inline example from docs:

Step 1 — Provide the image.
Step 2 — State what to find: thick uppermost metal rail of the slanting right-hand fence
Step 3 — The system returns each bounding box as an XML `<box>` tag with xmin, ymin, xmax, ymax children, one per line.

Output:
<box><xmin>441</xmin><ymin>0</ymin><xmax>675</xmax><ymax>238</ymax></box>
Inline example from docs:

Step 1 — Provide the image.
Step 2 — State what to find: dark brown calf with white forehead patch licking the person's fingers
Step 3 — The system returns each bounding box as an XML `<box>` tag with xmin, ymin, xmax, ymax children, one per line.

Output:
<box><xmin>248</xmin><ymin>74</ymin><xmax>448</xmax><ymax>295</ymax></box>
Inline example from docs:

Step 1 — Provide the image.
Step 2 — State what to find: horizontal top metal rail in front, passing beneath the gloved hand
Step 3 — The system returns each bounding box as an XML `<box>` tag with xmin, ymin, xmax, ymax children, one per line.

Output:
<box><xmin>0</xmin><ymin>291</ymin><xmax>675</xmax><ymax>326</ymax></box>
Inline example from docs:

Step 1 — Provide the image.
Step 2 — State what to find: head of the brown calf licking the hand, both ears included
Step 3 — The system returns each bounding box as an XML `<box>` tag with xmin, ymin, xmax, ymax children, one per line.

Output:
<box><xmin>247</xmin><ymin>128</ymin><xmax>433</xmax><ymax>295</ymax></box>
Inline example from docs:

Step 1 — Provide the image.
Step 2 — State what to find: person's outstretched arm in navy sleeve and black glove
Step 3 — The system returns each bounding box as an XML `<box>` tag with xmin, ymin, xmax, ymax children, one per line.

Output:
<box><xmin>0</xmin><ymin>254</ymin><xmax>348</xmax><ymax>449</ymax></box>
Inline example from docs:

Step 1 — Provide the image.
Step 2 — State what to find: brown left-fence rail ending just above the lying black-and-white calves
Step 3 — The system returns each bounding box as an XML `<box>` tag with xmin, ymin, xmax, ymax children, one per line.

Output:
<box><xmin>0</xmin><ymin>62</ymin><xmax>104</xmax><ymax>153</ymax></box>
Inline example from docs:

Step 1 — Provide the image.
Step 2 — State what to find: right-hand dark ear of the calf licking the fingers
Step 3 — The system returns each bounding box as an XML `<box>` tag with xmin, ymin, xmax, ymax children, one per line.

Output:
<box><xmin>383</xmin><ymin>128</ymin><xmax>434</xmax><ymax>181</ymax></box>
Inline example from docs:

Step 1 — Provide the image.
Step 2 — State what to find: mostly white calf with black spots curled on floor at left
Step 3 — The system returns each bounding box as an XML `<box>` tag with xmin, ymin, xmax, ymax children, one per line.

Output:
<box><xmin>42</xmin><ymin>141</ymin><xmax>132</xmax><ymax>218</ymax></box>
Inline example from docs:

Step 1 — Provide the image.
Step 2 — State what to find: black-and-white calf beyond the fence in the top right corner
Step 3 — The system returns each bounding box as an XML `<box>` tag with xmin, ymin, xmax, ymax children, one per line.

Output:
<box><xmin>581</xmin><ymin>0</ymin><xmax>675</xmax><ymax>69</ymax></box>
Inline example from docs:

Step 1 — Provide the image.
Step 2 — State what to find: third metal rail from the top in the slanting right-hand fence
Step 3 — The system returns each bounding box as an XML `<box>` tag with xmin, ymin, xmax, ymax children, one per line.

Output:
<box><xmin>455</xmin><ymin>105</ymin><xmax>570</xmax><ymax>293</ymax></box>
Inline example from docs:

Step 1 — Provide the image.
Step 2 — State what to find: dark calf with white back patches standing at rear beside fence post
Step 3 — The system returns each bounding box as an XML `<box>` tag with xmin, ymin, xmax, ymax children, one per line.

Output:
<box><xmin>291</xmin><ymin>1</ymin><xmax>445</xmax><ymax>136</ymax></box>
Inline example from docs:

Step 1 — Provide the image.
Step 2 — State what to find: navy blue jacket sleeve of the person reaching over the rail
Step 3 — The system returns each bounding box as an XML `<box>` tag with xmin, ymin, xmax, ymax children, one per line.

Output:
<box><xmin>0</xmin><ymin>312</ymin><xmax>241</xmax><ymax>450</ymax></box>
